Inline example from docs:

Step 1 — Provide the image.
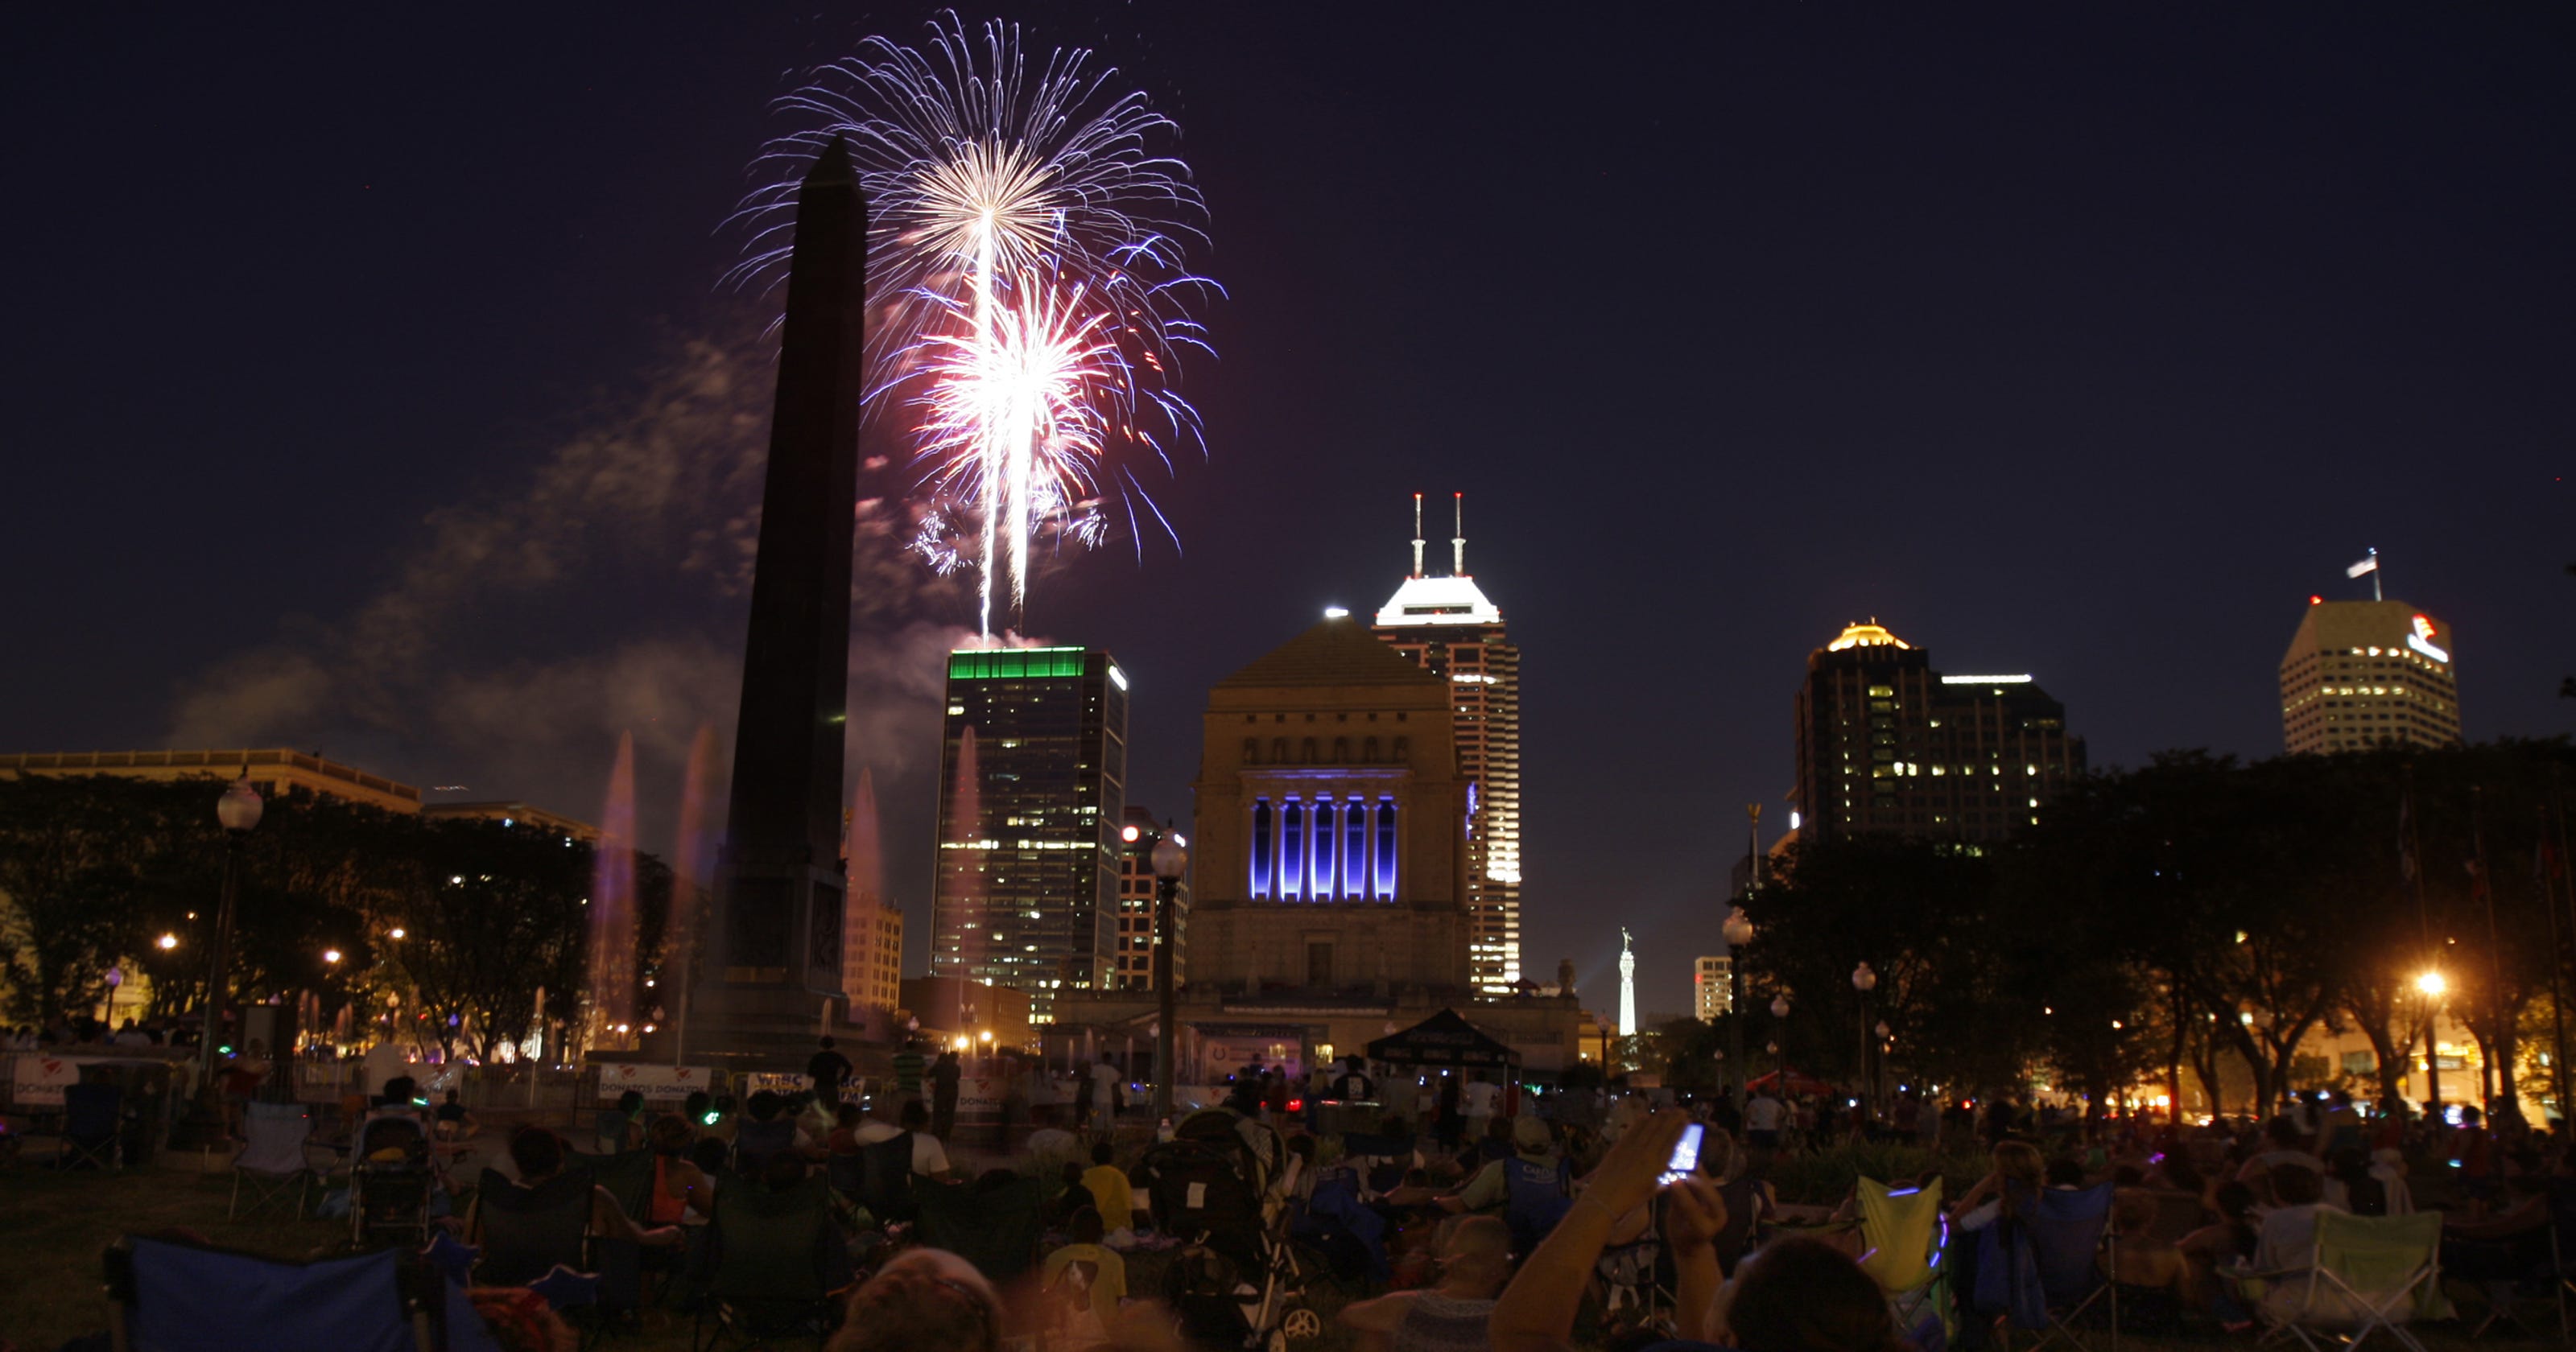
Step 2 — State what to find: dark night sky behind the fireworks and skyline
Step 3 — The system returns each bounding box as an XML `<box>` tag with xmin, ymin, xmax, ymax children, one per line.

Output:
<box><xmin>0</xmin><ymin>2</ymin><xmax>2576</xmax><ymax>1012</ymax></box>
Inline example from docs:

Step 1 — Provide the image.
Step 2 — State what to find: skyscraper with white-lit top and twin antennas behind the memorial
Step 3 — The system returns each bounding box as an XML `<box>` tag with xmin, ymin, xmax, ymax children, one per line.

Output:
<box><xmin>1376</xmin><ymin>494</ymin><xmax>1520</xmax><ymax>994</ymax></box>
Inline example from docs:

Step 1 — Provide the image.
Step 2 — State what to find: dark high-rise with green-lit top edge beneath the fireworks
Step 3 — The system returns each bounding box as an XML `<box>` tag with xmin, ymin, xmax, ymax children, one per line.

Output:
<box><xmin>930</xmin><ymin>649</ymin><xmax>1129</xmax><ymax>1022</ymax></box>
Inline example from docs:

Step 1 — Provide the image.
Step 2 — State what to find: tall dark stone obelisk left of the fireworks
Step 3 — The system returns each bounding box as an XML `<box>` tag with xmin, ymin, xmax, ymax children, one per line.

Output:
<box><xmin>680</xmin><ymin>139</ymin><xmax>868</xmax><ymax>1069</ymax></box>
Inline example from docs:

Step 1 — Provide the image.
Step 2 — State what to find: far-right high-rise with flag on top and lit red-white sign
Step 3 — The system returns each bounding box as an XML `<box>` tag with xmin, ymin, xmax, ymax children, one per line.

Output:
<box><xmin>2280</xmin><ymin>600</ymin><xmax>2460</xmax><ymax>755</ymax></box>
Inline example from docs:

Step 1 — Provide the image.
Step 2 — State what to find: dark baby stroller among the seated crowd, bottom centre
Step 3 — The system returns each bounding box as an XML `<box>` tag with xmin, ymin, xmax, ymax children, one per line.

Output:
<box><xmin>1138</xmin><ymin>1110</ymin><xmax>1324</xmax><ymax>1352</ymax></box>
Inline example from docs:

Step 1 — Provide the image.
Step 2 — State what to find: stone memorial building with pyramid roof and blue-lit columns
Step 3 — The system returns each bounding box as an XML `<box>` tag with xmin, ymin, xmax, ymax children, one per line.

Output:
<box><xmin>1059</xmin><ymin>613</ymin><xmax>1582</xmax><ymax>1076</ymax></box>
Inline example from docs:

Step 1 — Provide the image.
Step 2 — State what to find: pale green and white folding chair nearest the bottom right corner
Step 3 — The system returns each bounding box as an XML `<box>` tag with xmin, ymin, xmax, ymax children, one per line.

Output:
<box><xmin>2254</xmin><ymin>1210</ymin><xmax>2450</xmax><ymax>1352</ymax></box>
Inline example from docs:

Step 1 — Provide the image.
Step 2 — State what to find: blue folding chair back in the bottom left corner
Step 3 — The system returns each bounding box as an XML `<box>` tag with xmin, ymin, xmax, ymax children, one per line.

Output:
<box><xmin>108</xmin><ymin>1236</ymin><xmax>415</xmax><ymax>1352</ymax></box>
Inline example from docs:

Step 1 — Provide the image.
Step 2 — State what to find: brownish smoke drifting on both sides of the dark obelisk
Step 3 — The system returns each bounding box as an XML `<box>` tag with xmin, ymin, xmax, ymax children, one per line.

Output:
<box><xmin>167</xmin><ymin>314</ymin><xmax>994</xmax><ymax>942</ymax></box>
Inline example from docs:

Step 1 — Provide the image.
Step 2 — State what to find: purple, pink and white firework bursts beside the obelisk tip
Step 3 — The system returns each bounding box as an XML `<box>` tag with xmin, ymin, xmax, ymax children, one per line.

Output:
<box><xmin>734</xmin><ymin>10</ymin><xmax>1221</xmax><ymax>633</ymax></box>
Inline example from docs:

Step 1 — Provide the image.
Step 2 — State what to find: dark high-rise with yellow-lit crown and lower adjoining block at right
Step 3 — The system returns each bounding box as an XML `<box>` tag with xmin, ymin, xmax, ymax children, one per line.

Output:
<box><xmin>1795</xmin><ymin>620</ymin><xmax>2084</xmax><ymax>842</ymax></box>
